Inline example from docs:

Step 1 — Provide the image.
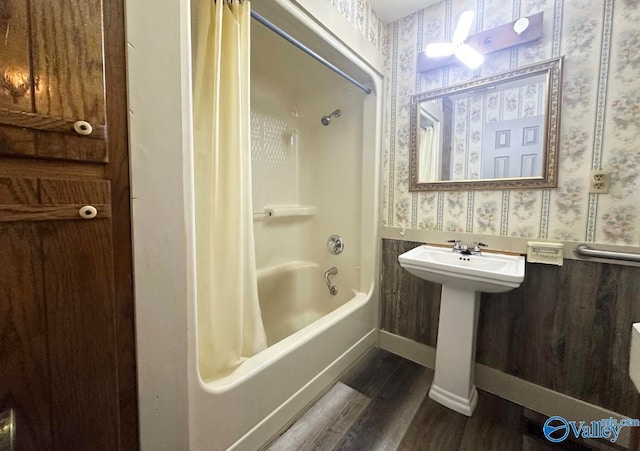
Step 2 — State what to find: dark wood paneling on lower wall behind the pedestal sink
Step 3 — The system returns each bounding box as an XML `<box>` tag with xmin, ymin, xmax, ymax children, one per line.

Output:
<box><xmin>381</xmin><ymin>240</ymin><xmax>640</xmax><ymax>417</ymax></box>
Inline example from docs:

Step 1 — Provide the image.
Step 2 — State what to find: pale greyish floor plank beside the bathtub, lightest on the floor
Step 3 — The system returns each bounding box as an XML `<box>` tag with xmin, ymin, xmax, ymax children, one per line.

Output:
<box><xmin>268</xmin><ymin>382</ymin><xmax>370</xmax><ymax>451</ymax></box>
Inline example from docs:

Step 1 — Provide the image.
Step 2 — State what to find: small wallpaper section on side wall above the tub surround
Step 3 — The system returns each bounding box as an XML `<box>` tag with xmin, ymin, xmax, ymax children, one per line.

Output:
<box><xmin>327</xmin><ymin>0</ymin><xmax>389</xmax><ymax>56</ymax></box>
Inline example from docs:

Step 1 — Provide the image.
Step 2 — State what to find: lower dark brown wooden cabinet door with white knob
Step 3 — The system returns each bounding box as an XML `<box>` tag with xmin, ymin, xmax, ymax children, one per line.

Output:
<box><xmin>0</xmin><ymin>178</ymin><xmax>119</xmax><ymax>451</ymax></box>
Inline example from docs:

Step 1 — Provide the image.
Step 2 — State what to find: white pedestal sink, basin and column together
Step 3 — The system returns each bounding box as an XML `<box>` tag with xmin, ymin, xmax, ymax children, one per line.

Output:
<box><xmin>398</xmin><ymin>245</ymin><xmax>524</xmax><ymax>416</ymax></box>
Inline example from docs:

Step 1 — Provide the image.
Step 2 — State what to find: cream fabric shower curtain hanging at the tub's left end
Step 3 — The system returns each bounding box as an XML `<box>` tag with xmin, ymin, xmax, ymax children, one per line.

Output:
<box><xmin>194</xmin><ymin>0</ymin><xmax>266</xmax><ymax>379</ymax></box>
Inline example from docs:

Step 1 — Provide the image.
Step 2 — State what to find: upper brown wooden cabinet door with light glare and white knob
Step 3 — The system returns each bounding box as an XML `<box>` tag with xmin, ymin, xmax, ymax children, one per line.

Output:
<box><xmin>0</xmin><ymin>0</ymin><xmax>108</xmax><ymax>162</ymax></box>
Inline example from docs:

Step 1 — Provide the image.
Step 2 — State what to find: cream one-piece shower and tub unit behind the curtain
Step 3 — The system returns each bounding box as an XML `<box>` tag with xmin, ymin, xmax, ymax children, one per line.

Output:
<box><xmin>189</xmin><ymin>1</ymin><xmax>381</xmax><ymax>450</ymax></box>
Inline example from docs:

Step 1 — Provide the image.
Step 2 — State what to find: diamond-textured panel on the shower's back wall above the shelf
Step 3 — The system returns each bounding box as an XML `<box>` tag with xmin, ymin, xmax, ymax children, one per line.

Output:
<box><xmin>251</xmin><ymin>111</ymin><xmax>300</xmax><ymax>211</ymax></box>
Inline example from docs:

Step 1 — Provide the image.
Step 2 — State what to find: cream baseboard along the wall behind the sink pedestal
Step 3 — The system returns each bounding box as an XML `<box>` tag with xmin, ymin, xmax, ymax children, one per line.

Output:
<box><xmin>378</xmin><ymin>330</ymin><xmax>630</xmax><ymax>447</ymax></box>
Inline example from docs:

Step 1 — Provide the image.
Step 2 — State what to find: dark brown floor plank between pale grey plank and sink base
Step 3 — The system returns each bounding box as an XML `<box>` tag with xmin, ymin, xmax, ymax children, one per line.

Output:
<box><xmin>334</xmin><ymin>360</ymin><xmax>433</xmax><ymax>450</ymax></box>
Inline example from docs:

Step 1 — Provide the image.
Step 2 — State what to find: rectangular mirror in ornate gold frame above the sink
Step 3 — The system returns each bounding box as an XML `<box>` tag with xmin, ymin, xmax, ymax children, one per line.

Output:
<box><xmin>409</xmin><ymin>57</ymin><xmax>562</xmax><ymax>191</ymax></box>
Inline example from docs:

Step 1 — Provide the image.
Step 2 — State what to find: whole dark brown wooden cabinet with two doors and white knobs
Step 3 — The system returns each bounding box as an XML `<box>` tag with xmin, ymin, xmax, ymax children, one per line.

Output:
<box><xmin>0</xmin><ymin>0</ymin><xmax>138</xmax><ymax>451</ymax></box>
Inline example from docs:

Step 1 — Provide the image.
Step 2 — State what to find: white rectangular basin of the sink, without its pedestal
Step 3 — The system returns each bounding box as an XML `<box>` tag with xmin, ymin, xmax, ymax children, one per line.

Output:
<box><xmin>398</xmin><ymin>245</ymin><xmax>524</xmax><ymax>293</ymax></box>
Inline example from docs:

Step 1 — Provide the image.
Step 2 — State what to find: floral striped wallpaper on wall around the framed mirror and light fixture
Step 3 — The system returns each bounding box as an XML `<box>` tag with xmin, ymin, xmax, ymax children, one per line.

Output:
<box><xmin>382</xmin><ymin>0</ymin><xmax>640</xmax><ymax>246</ymax></box>
